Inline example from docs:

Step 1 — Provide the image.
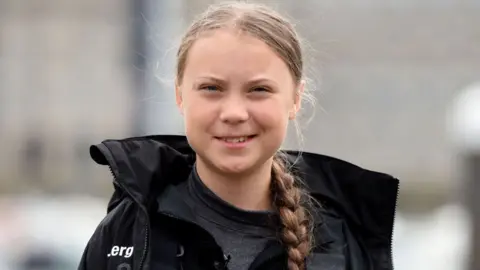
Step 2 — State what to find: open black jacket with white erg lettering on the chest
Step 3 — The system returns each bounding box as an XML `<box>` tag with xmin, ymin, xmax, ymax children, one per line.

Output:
<box><xmin>78</xmin><ymin>135</ymin><xmax>399</xmax><ymax>270</ymax></box>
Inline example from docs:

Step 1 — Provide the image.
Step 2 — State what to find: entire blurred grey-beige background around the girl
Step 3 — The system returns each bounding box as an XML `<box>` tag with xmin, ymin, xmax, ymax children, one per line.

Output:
<box><xmin>0</xmin><ymin>0</ymin><xmax>480</xmax><ymax>270</ymax></box>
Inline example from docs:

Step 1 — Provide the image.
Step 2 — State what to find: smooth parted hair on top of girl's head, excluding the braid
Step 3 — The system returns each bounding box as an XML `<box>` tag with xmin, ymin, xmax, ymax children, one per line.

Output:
<box><xmin>177</xmin><ymin>2</ymin><xmax>303</xmax><ymax>83</ymax></box>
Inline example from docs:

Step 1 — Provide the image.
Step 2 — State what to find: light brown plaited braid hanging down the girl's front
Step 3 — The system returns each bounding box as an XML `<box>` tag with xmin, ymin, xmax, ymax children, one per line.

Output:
<box><xmin>272</xmin><ymin>154</ymin><xmax>312</xmax><ymax>270</ymax></box>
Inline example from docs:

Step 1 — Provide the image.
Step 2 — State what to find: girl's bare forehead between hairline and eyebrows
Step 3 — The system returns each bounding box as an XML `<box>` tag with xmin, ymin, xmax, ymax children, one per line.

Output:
<box><xmin>185</xmin><ymin>30</ymin><xmax>293</xmax><ymax>83</ymax></box>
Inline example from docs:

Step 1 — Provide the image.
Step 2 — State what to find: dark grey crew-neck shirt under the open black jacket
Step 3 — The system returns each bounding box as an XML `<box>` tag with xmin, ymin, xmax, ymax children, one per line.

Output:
<box><xmin>180</xmin><ymin>170</ymin><xmax>276</xmax><ymax>270</ymax></box>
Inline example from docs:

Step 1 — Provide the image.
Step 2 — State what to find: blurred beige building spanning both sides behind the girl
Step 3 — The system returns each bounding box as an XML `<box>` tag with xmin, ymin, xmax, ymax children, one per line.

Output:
<box><xmin>0</xmin><ymin>0</ymin><xmax>480</xmax><ymax>205</ymax></box>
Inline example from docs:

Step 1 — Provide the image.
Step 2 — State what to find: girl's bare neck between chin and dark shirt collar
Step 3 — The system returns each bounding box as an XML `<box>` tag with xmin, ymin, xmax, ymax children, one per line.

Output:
<box><xmin>196</xmin><ymin>158</ymin><xmax>272</xmax><ymax>211</ymax></box>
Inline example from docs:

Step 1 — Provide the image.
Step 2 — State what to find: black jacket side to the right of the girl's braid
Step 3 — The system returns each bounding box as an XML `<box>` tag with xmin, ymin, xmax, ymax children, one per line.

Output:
<box><xmin>289</xmin><ymin>152</ymin><xmax>399</xmax><ymax>269</ymax></box>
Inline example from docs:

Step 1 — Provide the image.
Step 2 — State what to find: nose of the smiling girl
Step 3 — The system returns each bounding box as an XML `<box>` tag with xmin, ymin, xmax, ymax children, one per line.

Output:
<box><xmin>220</xmin><ymin>94</ymin><xmax>249</xmax><ymax>124</ymax></box>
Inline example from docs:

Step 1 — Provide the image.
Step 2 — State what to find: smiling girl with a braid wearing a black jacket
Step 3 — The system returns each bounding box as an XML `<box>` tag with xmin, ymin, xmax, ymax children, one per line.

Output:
<box><xmin>79</xmin><ymin>3</ymin><xmax>398</xmax><ymax>270</ymax></box>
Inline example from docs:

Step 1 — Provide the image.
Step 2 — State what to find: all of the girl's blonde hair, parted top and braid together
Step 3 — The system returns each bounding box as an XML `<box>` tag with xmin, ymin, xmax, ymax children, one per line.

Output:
<box><xmin>176</xmin><ymin>2</ymin><xmax>313</xmax><ymax>270</ymax></box>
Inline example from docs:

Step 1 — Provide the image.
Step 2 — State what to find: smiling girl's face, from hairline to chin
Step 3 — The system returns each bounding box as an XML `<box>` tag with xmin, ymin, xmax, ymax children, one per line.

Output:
<box><xmin>176</xmin><ymin>30</ymin><xmax>303</xmax><ymax>174</ymax></box>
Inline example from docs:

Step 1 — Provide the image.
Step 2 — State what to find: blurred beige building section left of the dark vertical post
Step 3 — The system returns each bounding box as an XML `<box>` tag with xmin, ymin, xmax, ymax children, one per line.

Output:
<box><xmin>0</xmin><ymin>0</ymin><xmax>133</xmax><ymax>192</ymax></box>
